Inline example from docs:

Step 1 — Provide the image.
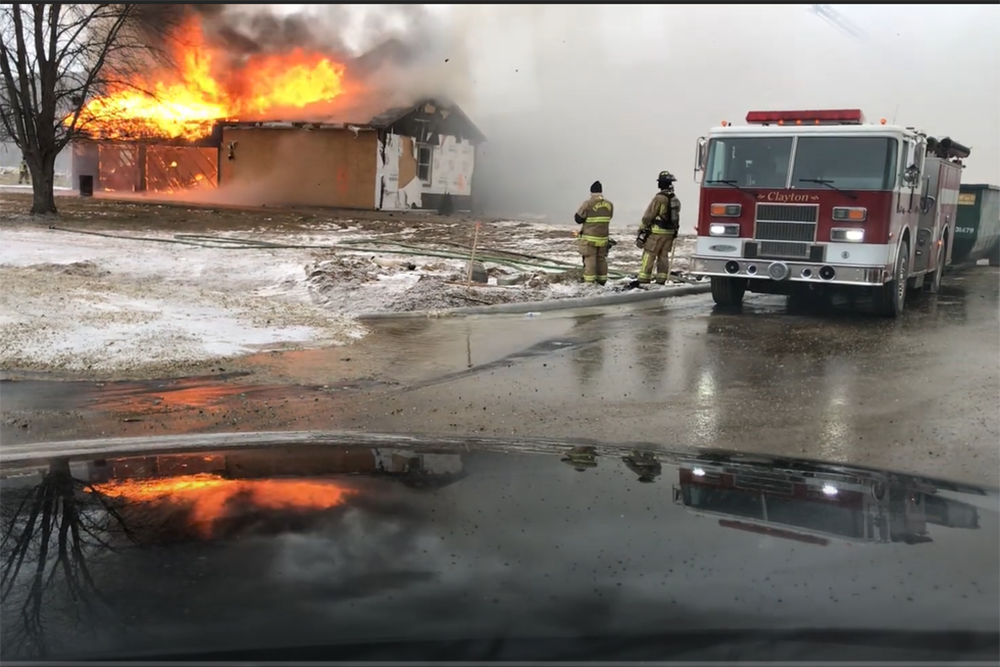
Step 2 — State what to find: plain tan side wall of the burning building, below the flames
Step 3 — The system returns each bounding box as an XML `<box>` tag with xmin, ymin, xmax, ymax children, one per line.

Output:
<box><xmin>219</xmin><ymin>127</ymin><xmax>381</xmax><ymax>209</ymax></box>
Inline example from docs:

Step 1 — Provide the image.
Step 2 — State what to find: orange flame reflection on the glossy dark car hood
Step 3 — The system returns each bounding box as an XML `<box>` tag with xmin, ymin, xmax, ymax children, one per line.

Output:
<box><xmin>94</xmin><ymin>473</ymin><xmax>354</xmax><ymax>538</ymax></box>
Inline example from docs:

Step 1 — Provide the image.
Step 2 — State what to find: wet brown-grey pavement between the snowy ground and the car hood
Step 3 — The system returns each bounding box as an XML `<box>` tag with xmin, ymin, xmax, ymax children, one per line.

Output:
<box><xmin>0</xmin><ymin>267</ymin><xmax>1000</xmax><ymax>482</ymax></box>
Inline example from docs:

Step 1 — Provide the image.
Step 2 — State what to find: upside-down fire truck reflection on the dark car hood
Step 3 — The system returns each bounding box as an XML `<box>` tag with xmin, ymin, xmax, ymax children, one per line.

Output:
<box><xmin>674</xmin><ymin>458</ymin><xmax>979</xmax><ymax>546</ymax></box>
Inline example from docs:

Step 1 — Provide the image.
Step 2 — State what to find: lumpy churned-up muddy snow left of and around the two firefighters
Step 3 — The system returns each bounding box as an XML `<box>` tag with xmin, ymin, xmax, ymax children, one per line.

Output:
<box><xmin>204</xmin><ymin>220</ymin><xmax>695</xmax><ymax>315</ymax></box>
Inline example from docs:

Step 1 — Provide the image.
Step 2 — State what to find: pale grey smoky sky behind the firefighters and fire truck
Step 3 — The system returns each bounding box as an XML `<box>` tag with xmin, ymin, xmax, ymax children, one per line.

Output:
<box><xmin>453</xmin><ymin>5</ymin><xmax>1000</xmax><ymax>222</ymax></box>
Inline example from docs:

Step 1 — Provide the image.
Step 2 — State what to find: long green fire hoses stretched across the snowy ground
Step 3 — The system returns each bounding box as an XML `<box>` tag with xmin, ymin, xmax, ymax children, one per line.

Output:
<box><xmin>49</xmin><ymin>225</ymin><xmax>626</xmax><ymax>278</ymax></box>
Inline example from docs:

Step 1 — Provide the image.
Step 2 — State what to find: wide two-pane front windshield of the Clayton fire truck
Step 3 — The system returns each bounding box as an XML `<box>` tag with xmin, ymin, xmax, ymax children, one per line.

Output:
<box><xmin>703</xmin><ymin>136</ymin><xmax>898</xmax><ymax>191</ymax></box>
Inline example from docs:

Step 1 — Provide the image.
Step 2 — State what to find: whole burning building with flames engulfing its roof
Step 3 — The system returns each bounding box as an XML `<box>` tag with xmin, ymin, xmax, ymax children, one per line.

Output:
<box><xmin>73</xmin><ymin>13</ymin><xmax>485</xmax><ymax>211</ymax></box>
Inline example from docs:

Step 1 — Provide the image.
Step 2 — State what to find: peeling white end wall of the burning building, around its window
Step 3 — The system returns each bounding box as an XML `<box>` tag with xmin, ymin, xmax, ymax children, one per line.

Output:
<box><xmin>379</xmin><ymin>133</ymin><xmax>476</xmax><ymax>211</ymax></box>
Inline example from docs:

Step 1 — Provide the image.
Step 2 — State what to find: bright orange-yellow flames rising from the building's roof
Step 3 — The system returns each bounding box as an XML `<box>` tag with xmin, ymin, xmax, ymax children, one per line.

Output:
<box><xmin>73</xmin><ymin>19</ymin><xmax>346</xmax><ymax>139</ymax></box>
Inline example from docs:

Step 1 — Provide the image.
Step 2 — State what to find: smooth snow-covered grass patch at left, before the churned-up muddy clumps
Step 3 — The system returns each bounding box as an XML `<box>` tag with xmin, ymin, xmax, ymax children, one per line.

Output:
<box><xmin>0</xmin><ymin>228</ymin><xmax>364</xmax><ymax>374</ymax></box>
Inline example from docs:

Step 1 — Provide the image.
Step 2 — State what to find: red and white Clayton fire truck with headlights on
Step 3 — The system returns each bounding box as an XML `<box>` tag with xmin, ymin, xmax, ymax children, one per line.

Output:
<box><xmin>692</xmin><ymin>109</ymin><xmax>969</xmax><ymax>317</ymax></box>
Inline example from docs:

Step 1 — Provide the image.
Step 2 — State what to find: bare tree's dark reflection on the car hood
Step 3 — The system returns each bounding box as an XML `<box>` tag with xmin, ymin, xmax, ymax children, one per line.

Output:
<box><xmin>0</xmin><ymin>459</ymin><xmax>134</xmax><ymax>657</ymax></box>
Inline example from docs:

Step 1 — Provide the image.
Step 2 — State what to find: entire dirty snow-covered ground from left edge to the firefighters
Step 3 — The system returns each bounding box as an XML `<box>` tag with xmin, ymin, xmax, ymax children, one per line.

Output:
<box><xmin>0</xmin><ymin>220</ymin><xmax>696</xmax><ymax>376</ymax></box>
